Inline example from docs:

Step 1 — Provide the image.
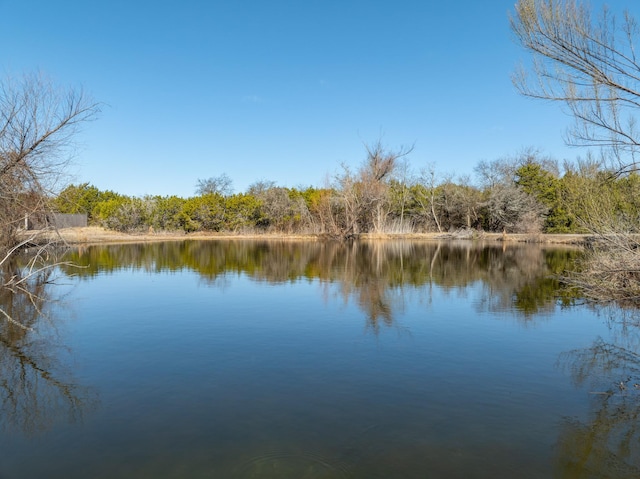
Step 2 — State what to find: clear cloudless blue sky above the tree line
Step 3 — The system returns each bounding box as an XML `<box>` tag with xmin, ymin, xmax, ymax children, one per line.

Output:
<box><xmin>0</xmin><ymin>0</ymin><xmax>592</xmax><ymax>197</ymax></box>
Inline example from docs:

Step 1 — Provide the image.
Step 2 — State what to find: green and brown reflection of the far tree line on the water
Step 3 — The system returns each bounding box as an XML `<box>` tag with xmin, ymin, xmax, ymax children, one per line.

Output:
<box><xmin>61</xmin><ymin>240</ymin><xmax>579</xmax><ymax>331</ymax></box>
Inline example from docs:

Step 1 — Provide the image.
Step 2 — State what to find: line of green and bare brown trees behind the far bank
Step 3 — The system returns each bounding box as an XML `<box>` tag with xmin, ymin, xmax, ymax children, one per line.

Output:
<box><xmin>52</xmin><ymin>142</ymin><xmax>640</xmax><ymax>238</ymax></box>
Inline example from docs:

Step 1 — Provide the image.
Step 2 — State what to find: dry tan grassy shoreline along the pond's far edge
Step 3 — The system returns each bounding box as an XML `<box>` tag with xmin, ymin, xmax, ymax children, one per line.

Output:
<box><xmin>28</xmin><ymin>226</ymin><xmax>593</xmax><ymax>246</ymax></box>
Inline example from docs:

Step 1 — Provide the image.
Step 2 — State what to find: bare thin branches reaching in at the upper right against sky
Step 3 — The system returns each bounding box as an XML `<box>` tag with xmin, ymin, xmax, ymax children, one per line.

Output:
<box><xmin>511</xmin><ymin>0</ymin><xmax>640</xmax><ymax>174</ymax></box>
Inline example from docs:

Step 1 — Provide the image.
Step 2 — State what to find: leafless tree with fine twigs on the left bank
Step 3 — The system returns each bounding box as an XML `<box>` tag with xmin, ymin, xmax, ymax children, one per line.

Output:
<box><xmin>0</xmin><ymin>74</ymin><xmax>100</xmax><ymax>328</ymax></box>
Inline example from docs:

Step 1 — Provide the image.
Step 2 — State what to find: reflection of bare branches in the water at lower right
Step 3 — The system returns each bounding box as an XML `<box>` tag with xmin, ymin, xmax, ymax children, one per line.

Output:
<box><xmin>556</xmin><ymin>307</ymin><xmax>640</xmax><ymax>479</ymax></box>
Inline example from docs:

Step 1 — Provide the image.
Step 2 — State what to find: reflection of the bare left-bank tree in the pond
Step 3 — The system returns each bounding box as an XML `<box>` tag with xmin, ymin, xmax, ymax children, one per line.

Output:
<box><xmin>0</xmin><ymin>265</ymin><xmax>96</xmax><ymax>435</ymax></box>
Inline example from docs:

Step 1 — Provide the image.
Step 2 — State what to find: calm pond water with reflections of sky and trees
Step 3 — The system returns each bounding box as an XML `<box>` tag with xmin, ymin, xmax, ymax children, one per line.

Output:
<box><xmin>0</xmin><ymin>241</ymin><xmax>640</xmax><ymax>479</ymax></box>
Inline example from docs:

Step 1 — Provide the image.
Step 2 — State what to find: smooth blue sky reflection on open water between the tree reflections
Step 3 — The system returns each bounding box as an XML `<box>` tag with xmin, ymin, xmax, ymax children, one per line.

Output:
<box><xmin>0</xmin><ymin>270</ymin><xmax>624</xmax><ymax>477</ymax></box>
